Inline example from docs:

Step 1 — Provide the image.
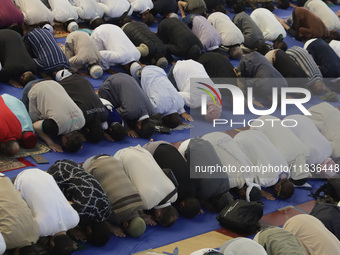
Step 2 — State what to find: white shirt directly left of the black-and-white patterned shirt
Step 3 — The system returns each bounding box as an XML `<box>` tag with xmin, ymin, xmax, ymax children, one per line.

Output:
<box><xmin>14</xmin><ymin>168</ymin><xmax>79</xmax><ymax>236</ymax></box>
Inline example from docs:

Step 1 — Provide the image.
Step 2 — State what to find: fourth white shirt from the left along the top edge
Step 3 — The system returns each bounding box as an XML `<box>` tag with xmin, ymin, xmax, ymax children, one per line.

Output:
<box><xmin>97</xmin><ymin>0</ymin><xmax>133</xmax><ymax>19</ymax></box>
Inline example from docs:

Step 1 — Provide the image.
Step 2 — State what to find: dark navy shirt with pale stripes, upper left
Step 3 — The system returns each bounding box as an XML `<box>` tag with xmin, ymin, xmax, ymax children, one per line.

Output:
<box><xmin>27</xmin><ymin>28</ymin><xmax>70</xmax><ymax>72</ymax></box>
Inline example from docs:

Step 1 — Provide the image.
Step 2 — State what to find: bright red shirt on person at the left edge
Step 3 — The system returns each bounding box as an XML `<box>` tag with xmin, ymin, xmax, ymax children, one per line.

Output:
<box><xmin>0</xmin><ymin>96</ymin><xmax>22</xmax><ymax>142</ymax></box>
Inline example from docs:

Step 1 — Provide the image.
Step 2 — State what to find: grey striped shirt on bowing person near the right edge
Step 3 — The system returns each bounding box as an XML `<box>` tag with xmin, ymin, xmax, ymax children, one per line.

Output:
<box><xmin>286</xmin><ymin>46</ymin><xmax>323</xmax><ymax>87</ymax></box>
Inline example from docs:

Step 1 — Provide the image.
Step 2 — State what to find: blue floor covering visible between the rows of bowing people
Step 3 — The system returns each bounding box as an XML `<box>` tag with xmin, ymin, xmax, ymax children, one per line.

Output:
<box><xmin>0</xmin><ymin>3</ymin><xmax>339</xmax><ymax>255</ymax></box>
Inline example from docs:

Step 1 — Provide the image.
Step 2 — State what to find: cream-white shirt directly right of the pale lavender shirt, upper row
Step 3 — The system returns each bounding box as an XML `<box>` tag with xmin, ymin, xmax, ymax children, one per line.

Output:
<box><xmin>208</xmin><ymin>12</ymin><xmax>244</xmax><ymax>46</ymax></box>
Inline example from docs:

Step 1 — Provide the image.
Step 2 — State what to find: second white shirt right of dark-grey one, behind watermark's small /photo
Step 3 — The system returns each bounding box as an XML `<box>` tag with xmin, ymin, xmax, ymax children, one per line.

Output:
<box><xmin>234</xmin><ymin>130</ymin><xmax>289</xmax><ymax>187</ymax></box>
